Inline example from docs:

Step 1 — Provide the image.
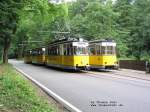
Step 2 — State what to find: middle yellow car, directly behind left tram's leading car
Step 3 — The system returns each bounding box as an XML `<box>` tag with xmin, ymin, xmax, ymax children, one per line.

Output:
<box><xmin>31</xmin><ymin>47</ymin><xmax>45</xmax><ymax>65</ymax></box>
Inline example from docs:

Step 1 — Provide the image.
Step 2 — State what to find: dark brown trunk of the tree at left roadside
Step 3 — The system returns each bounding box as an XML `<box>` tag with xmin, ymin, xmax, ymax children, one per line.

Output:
<box><xmin>3</xmin><ymin>39</ymin><xmax>10</xmax><ymax>64</ymax></box>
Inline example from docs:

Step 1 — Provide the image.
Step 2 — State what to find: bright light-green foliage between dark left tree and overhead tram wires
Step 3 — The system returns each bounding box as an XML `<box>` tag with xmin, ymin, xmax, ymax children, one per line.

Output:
<box><xmin>16</xmin><ymin>0</ymin><xmax>67</xmax><ymax>48</ymax></box>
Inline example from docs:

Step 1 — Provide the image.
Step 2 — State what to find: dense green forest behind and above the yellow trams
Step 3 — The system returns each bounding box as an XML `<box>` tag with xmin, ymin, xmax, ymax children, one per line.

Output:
<box><xmin>0</xmin><ymin>0</ymin><xmax>150</xmax><ymax>63</ymax></box>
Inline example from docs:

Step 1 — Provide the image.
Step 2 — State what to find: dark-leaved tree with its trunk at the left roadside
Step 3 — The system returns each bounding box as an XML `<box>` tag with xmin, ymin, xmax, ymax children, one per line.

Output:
<box><xmin>0</xmin><ymin>0</ymin><xmax>29</xmax><ymax>63</ymax></box>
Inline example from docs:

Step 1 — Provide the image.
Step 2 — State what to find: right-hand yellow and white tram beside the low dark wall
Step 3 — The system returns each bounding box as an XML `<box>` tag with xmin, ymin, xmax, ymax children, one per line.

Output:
<box><xmin>89</xmin><ymin>39</ymin><xmax>118</xmax><ymax>69</ymax></box>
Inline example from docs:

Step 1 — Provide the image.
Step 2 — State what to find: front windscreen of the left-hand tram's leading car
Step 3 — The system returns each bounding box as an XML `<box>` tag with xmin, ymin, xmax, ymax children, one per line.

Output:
<box><xmin>74</xmin><ymin>47</ymin><xmax>88</xmax><ymax>55</ymax></box>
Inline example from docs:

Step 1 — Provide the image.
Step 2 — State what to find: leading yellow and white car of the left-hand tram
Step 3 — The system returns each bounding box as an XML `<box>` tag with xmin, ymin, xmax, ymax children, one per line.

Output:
<box><xmin>45</xmin><ymin>38</ymin><xmax>89</xmax><ymax>70</ymax></box>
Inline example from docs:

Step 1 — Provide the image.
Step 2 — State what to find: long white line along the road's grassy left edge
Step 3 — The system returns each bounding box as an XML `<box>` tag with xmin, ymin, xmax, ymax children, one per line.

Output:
<box><xmin>14</xmin><ymin>66</ymin><xmax>82</xmax><ymax>112</ymax></box>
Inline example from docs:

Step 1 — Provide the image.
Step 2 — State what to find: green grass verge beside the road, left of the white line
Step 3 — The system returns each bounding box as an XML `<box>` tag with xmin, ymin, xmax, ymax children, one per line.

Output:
<box><xmin>0</xmin><ymin>65</ymin><xmax>56</xmax><ymax>112</ymax></box>
